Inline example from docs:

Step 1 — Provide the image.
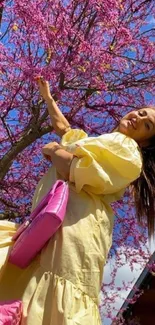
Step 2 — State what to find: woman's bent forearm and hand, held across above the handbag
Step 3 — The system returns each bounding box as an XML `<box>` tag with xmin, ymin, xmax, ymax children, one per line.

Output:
<box><xmin>42</xmin><ymin>142</ymin><xmax>74</xmax><ymax>180</ymax></box>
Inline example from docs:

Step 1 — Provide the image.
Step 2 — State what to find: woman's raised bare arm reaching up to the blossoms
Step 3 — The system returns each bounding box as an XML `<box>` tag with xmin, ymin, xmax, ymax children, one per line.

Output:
<box><xmin>37</xmin><ymin>77</ymin><xmax>70</xmax><ymax>137</ymax></box>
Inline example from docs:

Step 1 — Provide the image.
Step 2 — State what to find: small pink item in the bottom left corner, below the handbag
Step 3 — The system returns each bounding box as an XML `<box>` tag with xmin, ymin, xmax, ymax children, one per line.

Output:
<box><xmin>0</xmin><ymin>300</ymin><xmax>22</xmax><ymax>325</ymax></box>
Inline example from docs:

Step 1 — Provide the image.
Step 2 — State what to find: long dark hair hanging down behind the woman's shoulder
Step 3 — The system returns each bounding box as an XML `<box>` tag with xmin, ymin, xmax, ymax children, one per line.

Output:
<box><xmin>131</xmin><ymin>136</ymin><xmax>155</xmax><ymax>238</ymax></box>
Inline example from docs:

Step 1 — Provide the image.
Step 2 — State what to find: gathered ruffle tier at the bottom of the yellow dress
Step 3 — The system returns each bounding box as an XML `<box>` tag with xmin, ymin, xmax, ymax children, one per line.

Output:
<box><xmin>22</xmin><ymin>268</ymin><xmax>101</xmax><ymax>325</ymax></box>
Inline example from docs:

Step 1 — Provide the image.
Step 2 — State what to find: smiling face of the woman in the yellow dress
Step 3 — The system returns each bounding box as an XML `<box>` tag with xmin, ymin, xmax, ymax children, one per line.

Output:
<box><xmin>117</xmin><ymin>108</ymin><xmax>155</xmax><ymax>147</ymax></box>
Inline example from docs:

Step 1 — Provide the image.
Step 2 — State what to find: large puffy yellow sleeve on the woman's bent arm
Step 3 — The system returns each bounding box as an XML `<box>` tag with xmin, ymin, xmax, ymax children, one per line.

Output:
<box><xmin>67</xmin><ymin>132</ymin><xmax>142</xmax><ymax>195</ymax></box>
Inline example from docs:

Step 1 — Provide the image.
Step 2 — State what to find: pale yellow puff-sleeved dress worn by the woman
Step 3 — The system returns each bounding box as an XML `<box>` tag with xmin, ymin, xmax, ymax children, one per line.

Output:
<box><xmin>0</xmin><ymin>130</ymin><xmax>142</xmax><ymax>325</ymax></box>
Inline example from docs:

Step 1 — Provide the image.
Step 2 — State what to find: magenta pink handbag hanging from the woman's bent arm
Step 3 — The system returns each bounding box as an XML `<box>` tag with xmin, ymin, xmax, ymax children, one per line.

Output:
<box><xmin>9</xmin><ymin>181</ymin><xmax>69</xmax><ymax>268</ymax></box>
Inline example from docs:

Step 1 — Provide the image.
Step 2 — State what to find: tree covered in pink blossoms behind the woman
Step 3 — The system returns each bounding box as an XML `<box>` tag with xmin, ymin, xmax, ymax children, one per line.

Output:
<box><xmin>0</xmin><ymin>0</ymin><xmax>155</xmax><ymax>318</ymax></box>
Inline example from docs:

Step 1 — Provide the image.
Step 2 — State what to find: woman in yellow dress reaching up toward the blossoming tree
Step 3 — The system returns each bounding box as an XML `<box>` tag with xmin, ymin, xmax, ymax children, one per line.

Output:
<box><xmin>0</xmin><ymin>79</ymin><xmax>155</xmax><ymax>325</ymax></box>
